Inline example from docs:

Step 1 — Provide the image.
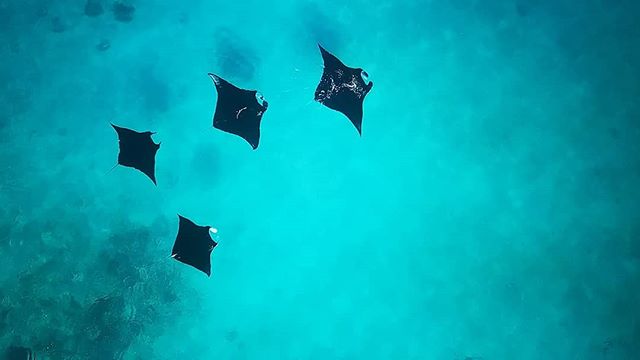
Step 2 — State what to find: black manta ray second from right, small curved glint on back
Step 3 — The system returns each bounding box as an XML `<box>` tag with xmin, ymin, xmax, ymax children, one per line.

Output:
<box><xmin>209</xmin><ymin>74</ymin><xmax>269</xmax><ymax>150</ymax></box>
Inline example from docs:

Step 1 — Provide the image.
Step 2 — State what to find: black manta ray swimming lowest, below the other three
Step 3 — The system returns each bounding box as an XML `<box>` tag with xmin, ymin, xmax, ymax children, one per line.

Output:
<box><xmin>171</xmin><ymin>215</ymin><xmax>218</xmax><ymax>276</ymax></box>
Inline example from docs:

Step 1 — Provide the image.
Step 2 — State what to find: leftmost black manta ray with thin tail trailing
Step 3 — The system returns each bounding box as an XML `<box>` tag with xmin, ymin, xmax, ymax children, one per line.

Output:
<box><xmin>111</xmin><ymin>124</ymin><xmax>160</xmax><ymax>185</ymax></box>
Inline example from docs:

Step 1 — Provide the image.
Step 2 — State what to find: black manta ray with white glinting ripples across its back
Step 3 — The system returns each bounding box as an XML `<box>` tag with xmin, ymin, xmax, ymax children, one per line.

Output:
<box><xmin>315</xmin><ymin>45</ymin><xmax>373</xmax><ymax>135</ymax></box>
